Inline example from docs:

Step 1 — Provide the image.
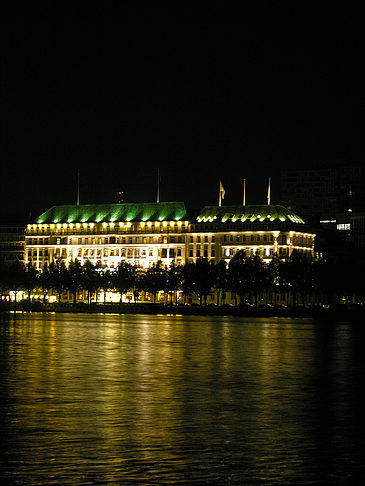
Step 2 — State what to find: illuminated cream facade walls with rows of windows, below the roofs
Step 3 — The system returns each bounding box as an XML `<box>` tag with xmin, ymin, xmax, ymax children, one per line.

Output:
<box><xmin>25</xmin><ymin>221</ymin><xmax>315</xmax><ymax>269</ymax></box>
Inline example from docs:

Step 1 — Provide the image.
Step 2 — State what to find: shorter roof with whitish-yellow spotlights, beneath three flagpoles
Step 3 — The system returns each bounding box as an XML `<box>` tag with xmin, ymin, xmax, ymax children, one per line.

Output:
<box><xmin>196</xmin><ymin>204</ymin><xmax>304</xmax><ymax>224</ymax></box>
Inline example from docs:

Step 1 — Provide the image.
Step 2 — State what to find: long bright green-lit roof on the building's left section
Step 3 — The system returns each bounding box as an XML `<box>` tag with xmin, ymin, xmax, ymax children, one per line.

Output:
<box><xmin>36</xmin><ymin>202</ymin><xmax>187</xmax><ymax>223</ymax></box>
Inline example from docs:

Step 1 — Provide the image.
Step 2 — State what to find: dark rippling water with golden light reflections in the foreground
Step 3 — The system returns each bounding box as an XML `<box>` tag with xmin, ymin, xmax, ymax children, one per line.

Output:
<box><xmin>0</xmin><ymin>314</ymin><xmax>365</xmax><ymax>485</ymax></box>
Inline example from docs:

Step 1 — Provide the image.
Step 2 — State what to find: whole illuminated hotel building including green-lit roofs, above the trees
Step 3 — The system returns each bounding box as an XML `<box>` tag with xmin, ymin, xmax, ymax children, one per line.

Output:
<box><xmin>25</xmin><ymin>202</ymin><xmax>315</xmax><ymax>270</ymax></box>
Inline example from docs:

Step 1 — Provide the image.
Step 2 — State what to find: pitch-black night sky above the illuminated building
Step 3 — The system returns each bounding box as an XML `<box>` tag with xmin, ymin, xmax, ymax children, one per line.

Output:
<box><xmin>1</xmin><ymin>6</ymin><xmax>365</xmax><ymax>218</ymax></box>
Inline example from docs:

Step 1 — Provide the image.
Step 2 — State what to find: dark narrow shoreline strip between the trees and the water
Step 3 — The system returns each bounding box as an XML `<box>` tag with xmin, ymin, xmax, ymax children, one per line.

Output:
<box><xmin>0</xmin><ymin>302</ymin><xmax>365</xmax><ymax>323</ymax></box>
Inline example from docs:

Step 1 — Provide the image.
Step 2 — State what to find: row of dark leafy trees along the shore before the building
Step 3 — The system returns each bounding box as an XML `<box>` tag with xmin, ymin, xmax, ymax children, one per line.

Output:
<box><xmin>0</xmin><ymin>251</ymin><xmax>365</xmax><ymax>312</ymax></box>
